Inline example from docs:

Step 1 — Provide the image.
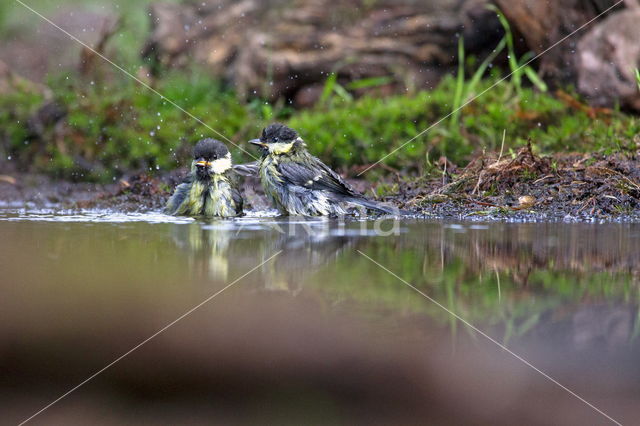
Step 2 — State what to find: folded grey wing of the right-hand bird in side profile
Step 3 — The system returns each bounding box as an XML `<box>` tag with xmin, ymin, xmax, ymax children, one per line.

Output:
<box><xmin>276</xmin><ymin>157</ymin><xmax>358</xmax><ymax>197</ymax></box>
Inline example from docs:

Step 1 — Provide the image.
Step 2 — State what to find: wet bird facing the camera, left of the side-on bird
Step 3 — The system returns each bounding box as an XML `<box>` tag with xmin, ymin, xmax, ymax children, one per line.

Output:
<box><xmin>164</xmin><ymin>138</ymin><xmax>243</xmax><ymax>217</ymax></box>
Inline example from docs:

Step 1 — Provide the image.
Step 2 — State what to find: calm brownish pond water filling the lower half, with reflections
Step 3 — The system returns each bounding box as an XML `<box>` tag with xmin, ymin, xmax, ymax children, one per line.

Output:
<box><xmin>0</xmin><ymin>208</ymin><xmax>640</xmax><ymax>424</ymax></box>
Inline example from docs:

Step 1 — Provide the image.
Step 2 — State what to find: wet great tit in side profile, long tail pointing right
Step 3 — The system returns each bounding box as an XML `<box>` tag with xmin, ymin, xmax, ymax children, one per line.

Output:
<box><xmin>249</xmin><ymin>123</ymin><xmax>397</xmax><ymax>216</ymax></box>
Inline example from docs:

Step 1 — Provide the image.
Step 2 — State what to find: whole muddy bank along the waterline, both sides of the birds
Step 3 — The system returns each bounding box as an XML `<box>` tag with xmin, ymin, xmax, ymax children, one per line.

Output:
<box><xmin>0</xmin><ymin>146</ymin><xmax>640</xmax><ymax>221</ymax></box>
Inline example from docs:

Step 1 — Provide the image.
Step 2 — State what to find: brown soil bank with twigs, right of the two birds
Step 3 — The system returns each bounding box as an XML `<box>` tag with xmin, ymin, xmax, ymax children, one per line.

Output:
<box><xmin>395</xmin><ymin>146</ymin><xmax>640</xmax><ymax>220</ymax></box>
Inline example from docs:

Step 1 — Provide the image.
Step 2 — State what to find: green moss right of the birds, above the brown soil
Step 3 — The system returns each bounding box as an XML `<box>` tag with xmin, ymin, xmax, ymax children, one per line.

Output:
<box><xmin>289</xmin><ymin>77</ymin><xmax>640</xmax><ymax>175</ymax></box>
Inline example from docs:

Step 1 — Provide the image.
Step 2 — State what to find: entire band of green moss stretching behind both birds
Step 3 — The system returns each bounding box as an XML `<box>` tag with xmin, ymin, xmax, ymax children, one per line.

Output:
<box><xmin>0</xmin><ymin>71</ymin><xmax>640</xmax><ymax>181</ymax></box>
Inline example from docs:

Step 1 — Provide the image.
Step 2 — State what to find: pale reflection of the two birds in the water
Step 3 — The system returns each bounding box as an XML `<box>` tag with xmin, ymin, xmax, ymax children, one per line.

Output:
<box><xmin>172</xmin><ymin>219</ymin><xmax>356</xmax><ymax>295</ymax></box>
